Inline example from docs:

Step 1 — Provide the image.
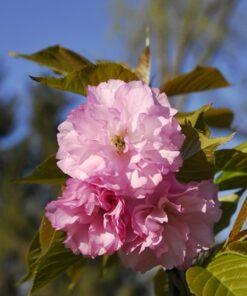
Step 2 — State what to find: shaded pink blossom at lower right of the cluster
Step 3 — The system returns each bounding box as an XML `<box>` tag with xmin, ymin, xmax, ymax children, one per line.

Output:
<box><xmin>120</xmin><ymin>174</ymin><xmax>221</xmax><ymax>272</ymax></box>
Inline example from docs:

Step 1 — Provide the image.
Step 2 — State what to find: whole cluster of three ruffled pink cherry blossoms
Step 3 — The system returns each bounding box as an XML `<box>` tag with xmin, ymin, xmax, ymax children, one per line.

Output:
<box><xmin>46</xmin><ymin>80</ymin><xmax>220</xmax><ymax>272</ymax></box>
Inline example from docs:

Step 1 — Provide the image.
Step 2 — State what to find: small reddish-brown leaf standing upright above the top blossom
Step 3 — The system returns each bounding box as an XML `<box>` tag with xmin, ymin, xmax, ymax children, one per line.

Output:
<box><xmin>135</xmin><ymin>45</ymin><xmax>151</xmax><ymax>84</ymax></box>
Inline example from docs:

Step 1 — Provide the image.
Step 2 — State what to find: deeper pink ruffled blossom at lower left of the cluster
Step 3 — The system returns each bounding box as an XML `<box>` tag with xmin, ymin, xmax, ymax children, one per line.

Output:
<box><xmin>46</xmin><ymin>179</ymin><xmax>128</xmax><ymax>258</ymax></box>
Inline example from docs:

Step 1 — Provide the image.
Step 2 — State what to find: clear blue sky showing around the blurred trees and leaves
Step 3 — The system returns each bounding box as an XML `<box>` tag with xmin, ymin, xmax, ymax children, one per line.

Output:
<box><xmin>0</xmin><ymin>0</ymin><xmax>247</xmax><ymax>148</ymax></box>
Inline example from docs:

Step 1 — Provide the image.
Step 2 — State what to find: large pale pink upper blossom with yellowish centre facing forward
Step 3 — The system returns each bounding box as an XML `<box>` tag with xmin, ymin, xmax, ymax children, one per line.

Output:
<box><xmin>57</xmin><ymin>80</ymin><xmax>184</xmax><ymax>198</ymax></box>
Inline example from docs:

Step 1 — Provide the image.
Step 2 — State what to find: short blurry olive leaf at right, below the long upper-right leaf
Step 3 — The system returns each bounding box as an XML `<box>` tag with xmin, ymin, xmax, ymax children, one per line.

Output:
<box><xmin>204</xmin><ymin>108</ymin><xmax>234</xmax><ymax>128</ymax></box>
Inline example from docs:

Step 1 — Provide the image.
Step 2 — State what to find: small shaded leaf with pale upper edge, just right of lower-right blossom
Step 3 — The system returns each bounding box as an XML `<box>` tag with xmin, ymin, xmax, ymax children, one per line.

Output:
<box><xmin>214</xmin><ymin>191</ymin><xmax>242</xmax><ymax>234</ymax></box>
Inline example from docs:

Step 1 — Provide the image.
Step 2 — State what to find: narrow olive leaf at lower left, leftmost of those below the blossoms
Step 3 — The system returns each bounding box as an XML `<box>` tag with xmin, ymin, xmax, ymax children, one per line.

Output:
<box><xmin>20</xmin><ymin>232</ymin><xmax>41</xmax><ymax>283</ymax></box>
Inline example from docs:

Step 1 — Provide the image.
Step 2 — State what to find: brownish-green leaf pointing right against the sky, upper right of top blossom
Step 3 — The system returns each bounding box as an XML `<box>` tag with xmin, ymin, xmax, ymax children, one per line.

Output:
<box><xmin>161</xmin><ymin>66</ymin><xmax>229</xmax><ymax>96</ymax></box>
